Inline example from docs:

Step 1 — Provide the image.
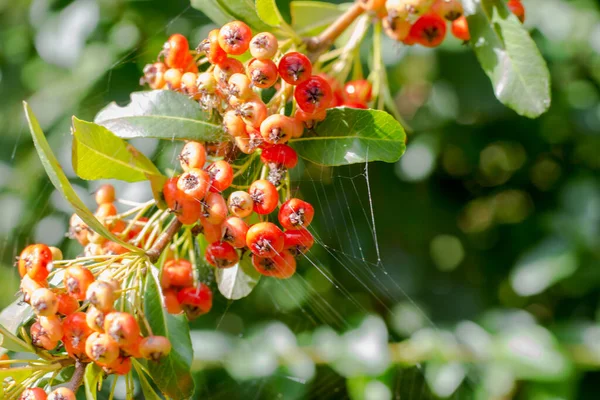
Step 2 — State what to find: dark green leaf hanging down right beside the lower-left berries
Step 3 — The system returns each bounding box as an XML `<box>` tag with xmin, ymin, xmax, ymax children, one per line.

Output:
<box><xmin>144</xmin><ymin>266</ymin><xmax>194</xmax><ymax>399</ymax></box>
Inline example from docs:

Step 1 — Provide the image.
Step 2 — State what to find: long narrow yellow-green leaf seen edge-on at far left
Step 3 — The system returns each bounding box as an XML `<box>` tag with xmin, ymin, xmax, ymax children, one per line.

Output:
<box><xmin>23</xmin><ymin>102</ymin><xmax>141</xmax><ymax>252</ymax></box>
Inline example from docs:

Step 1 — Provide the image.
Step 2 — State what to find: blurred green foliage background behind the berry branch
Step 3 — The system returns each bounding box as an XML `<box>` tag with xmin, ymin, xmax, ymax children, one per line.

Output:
<box><xmin>0</xmin><ymin>0</ymin><xmax>600</xmax><ymax>400</ymax></box>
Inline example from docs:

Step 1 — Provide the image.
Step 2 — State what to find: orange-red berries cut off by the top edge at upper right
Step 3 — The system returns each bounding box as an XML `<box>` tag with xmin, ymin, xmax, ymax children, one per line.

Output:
<box><xmin>360</xmin><ymin>0</ymin><xmax>525</xmax><ymax>47</ymax></box>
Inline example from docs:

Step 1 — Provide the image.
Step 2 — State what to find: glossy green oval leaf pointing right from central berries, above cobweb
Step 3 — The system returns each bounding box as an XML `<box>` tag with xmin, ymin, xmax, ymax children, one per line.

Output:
<box><xmin>290</xmin><ymin>107</ymin><xmax>406</xmax><ymax>166</ymax></box>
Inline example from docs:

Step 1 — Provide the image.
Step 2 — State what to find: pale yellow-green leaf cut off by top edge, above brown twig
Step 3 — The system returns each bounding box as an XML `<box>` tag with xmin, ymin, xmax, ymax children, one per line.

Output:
<box><xmin>290</xmin><ymin>1</ymin><xmax>351</xmax><ymax>36</ymax></box>
